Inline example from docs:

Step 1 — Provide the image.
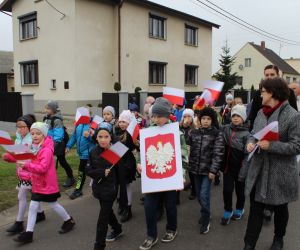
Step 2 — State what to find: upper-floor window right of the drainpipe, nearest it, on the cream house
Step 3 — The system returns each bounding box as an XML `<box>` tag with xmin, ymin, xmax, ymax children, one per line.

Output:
<box><xmin>149</xmin><ymin>14</ymin><xmax>166</xmax><ymax>39</ymax></box>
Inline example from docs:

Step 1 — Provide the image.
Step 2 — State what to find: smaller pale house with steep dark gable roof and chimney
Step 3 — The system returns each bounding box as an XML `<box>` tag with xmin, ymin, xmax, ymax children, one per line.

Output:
<box><xmin>220</xmin><ymin>41</ymin><xmax>300</xmax><ymax>89</ymax></box>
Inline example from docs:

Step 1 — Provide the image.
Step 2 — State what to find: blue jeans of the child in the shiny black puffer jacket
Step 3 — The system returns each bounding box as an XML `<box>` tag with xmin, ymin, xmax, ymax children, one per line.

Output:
<box><xmin>194</xmin><ymin>175</ymin><xmax>211</xmax><ymax>219</ymax></box>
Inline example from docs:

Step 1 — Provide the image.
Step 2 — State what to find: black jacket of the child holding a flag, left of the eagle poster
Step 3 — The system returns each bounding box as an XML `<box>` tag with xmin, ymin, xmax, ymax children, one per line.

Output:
<box><xmin>86</xmin><ymin>145</ymin><xmax>117</xmax><ymax>201</ymax></box>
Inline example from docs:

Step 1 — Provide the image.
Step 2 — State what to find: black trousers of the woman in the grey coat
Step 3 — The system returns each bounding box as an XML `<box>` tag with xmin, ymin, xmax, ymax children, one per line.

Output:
<box><xmin>244</xmin><ymin>191</ymin><xmax>289</xmax><ymax>247</ymax></box>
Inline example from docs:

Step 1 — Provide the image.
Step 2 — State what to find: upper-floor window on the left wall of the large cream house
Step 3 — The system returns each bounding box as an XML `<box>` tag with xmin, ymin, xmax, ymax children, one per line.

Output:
<box><xmin>18</xmin><ymin>12</ymin><xmax>37</xmax><ymax>40</ymax></box>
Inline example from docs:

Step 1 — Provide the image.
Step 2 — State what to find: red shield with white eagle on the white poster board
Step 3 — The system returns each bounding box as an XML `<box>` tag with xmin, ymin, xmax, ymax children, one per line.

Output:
<box><xmin>145</xmin><ymin>134</ymin><xmax>176</xmax><ymax>179</ymax></box>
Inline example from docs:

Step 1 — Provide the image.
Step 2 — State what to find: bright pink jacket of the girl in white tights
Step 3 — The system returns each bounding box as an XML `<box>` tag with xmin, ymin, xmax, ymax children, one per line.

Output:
<box><xmin>24</xmin><ymin>136</ymin><xmax>59</xmax><ymax>194</ymax></box>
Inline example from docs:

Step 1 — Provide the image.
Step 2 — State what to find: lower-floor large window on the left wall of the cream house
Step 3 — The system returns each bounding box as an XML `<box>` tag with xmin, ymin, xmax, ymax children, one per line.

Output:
<box><xmin>20</xmin><ymin>61</ymin><xmax>39</xmax><ymax>85</ymax></box>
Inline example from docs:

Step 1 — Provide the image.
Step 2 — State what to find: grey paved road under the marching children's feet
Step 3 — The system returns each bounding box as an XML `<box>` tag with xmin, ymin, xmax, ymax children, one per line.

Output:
<box><xmin>0</xmin><ymin>178</ymin><xmax>300</xmax><ymax>250</ymax></box>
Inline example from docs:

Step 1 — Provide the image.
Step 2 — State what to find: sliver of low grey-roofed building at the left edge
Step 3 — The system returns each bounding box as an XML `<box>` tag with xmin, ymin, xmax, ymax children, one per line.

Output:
<box><xmin>0</xmin><ymin>51</ymin><xmax>15</xmax><ymax>93</ymax></box>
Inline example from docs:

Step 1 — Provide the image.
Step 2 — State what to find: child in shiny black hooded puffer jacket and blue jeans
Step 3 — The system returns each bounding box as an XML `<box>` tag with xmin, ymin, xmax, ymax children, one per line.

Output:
<box><xmin>189</xmin><ymin>107</ymin><xmax>224</xmax><ymax>234</ymax></box>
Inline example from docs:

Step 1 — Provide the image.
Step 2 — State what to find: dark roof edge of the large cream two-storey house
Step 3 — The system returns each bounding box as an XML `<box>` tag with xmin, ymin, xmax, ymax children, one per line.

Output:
<box><xmin>0</xmin><ymin>0</ymin><xmax>220</xmax><ymax>28</ymax></box>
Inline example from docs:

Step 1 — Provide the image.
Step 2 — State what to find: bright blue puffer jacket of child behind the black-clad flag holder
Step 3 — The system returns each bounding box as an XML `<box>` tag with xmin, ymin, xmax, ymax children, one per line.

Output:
<box><xmin>67</xmin><ymin>124</ymin><xmax>95</xmax><ymax>160</ymax></box>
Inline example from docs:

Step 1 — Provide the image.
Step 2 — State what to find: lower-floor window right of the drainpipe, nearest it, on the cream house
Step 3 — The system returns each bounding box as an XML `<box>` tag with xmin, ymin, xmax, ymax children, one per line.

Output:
<box><xmin>149</xmin><ymin>62</ymin><xmax>167</xmax><ymax>84</ymax></box>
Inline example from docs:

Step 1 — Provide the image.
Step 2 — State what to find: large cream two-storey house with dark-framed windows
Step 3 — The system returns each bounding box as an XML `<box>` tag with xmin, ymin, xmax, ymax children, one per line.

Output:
<box><xmin>0</xmin><ymin>0</ymin><xmax>219</xmax><ymax>113</ymax></box>
